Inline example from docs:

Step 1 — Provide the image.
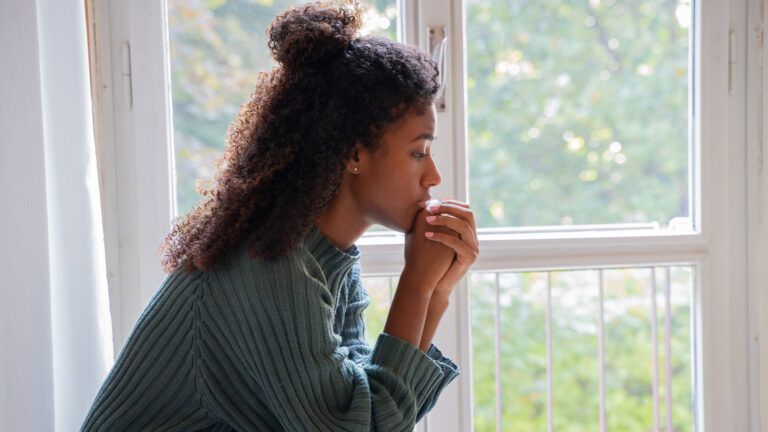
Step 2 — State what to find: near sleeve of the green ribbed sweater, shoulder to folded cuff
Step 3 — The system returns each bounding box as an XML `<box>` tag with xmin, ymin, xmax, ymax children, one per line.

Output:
<box><xmin>200</xmin><ymin>256</ymin><xmax>445</xmax><ymax>431</ymax></box>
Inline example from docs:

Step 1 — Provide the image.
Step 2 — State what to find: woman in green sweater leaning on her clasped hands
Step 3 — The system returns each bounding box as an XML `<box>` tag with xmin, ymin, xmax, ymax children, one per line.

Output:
<box><xmin>82</xmin><ymin>4</ymin><xmax>478</xmax><ymax>431</ymax></box>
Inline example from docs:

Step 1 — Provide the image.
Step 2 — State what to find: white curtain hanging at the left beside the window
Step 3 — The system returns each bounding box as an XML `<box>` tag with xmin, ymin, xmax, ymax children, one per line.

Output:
<box><xmin>0</xmin><ymin>0</ymin><xmax>113</xmax><ymax>432</ymax></box>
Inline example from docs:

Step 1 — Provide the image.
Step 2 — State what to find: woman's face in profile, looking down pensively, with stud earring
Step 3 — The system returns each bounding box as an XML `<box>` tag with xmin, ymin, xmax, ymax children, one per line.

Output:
<box><xmin>348</xmin><ymin>105</ymin><xmax>441</xmax><ymax>232</ymax></box>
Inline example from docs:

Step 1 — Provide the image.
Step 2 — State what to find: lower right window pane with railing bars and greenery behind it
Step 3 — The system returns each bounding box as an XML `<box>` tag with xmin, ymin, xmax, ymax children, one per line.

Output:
<box><xmin>470</xmin><ymin>266</ymin><xmax>694</xmax><ymax>432</ymax></box>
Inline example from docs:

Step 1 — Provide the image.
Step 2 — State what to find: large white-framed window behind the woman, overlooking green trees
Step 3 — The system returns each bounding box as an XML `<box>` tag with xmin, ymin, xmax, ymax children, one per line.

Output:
<box><xmin>91</xmin><ymin>0</ymin><xmax>750</xmax><ymax>431</ymax></box>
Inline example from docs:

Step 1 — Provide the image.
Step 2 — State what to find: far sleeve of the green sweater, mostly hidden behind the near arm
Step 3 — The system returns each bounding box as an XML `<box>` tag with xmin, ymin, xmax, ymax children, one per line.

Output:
<box><xmin>341</xmin><ymin>265</ymin><xmax>461</xmax><ymax>423</ymax></box>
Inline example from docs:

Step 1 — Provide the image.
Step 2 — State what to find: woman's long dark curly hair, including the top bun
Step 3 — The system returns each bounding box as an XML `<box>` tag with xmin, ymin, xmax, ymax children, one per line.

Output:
<box><xmin>160</xmin><ymin>2</ymin><xmax>440</xmax><ymax>272</ymax></box>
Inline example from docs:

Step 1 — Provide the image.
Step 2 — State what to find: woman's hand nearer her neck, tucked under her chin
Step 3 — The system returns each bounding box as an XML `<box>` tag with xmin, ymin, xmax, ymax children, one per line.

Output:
<box><xmin>401</xmin><ymin>209</ymin><xmax>456</xmax><ymax>293</ymax></box>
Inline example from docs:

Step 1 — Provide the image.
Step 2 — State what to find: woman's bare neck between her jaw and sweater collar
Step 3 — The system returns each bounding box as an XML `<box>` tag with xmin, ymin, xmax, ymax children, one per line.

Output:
<box><xmin>315</xmin><ymin>187</ymin><xmax>372</xmax><ymax>250</ymax></box>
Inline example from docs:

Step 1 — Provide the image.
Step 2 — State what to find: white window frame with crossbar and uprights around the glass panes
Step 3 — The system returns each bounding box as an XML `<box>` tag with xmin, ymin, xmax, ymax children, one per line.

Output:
<box><xmin>90</xmin><ymin>0</ymin><xmax>768</xmax><ymax>432</ymax></box>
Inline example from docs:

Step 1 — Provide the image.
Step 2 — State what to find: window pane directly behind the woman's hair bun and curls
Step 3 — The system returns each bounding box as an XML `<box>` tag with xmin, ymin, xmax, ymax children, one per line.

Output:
<box><xmin>168</xmin><ymin>0</ymin><xmax>398</xmax><ymax>214</ymax></box>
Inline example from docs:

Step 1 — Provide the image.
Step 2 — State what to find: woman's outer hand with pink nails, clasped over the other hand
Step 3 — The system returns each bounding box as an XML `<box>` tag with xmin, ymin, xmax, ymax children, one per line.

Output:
<box><xmin>420</xmin><ymin>199</ymin><xmax>480</xmax><ymax>299</ymax></box>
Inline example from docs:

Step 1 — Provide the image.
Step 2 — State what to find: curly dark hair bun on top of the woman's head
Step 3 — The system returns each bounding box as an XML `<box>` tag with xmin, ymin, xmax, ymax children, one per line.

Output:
<box><xmin>268</xmin><ymin>2</ymin><xmax>361</xmax><ymax>69</ymax></box>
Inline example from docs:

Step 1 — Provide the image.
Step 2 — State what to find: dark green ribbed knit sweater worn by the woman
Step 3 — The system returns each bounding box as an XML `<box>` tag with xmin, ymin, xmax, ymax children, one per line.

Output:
<box><xmin>81</xmin><ymin>227</ymin><xmax>460</xmax><ymax>432</ymax></box>
